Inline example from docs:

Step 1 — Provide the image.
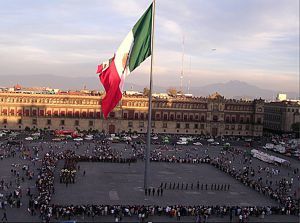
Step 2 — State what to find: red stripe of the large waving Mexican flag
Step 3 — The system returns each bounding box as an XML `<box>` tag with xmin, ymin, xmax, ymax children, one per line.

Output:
<box><xmin>97</xmin><ymin>58</ymin><xmax>122</xmax><ymax>119</ymax></box>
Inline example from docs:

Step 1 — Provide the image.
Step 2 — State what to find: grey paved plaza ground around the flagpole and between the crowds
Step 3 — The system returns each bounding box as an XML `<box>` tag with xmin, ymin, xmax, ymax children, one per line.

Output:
<box><xmin>0</xmin><ymin>133</ymin><xmax>299</xmax><ymax>222</ymax></box>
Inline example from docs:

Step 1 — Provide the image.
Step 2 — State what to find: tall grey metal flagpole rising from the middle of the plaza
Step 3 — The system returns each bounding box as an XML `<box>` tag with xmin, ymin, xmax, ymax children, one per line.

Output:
<box><xmin>144</xmin><ymin>0</ymin><xmax>155</xmax><ymax>189</ymax></box>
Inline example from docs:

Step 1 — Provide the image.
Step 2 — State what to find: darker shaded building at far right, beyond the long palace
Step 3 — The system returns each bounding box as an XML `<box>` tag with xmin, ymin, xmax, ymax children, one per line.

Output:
<box><xmin>264</xmin><ymin>101</ymin><xmax>300</xmax><ymax>133</ymax></box>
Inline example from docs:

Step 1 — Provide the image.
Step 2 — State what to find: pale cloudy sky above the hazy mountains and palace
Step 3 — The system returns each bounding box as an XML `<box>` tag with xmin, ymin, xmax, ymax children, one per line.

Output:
<box><xmin>0</xmin><ymin>0</ymin><xmax>300</xmax><ymax>92</ymax></box>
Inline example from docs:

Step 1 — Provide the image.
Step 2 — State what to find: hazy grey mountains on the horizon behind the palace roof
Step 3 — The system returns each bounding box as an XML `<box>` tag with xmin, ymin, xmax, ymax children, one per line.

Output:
<box><xmin>0</xmin><ymin>75</ymin><xmax>298</xmax><ymax>100</ymax></box>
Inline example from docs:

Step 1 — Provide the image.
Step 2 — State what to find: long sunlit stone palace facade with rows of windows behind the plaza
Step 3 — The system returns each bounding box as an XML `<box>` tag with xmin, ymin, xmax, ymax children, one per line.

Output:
<box><xmin>0</xmin><ymin>92</ymin><xmax>264</xmax><ymax>136</ymax></box>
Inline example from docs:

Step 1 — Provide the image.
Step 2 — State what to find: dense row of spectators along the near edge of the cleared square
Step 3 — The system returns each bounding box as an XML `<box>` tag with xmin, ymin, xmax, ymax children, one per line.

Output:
<box><xmin>41</xmin><ymin>204</ymin><xmax>296</xmax><ymax>223</ymax></box>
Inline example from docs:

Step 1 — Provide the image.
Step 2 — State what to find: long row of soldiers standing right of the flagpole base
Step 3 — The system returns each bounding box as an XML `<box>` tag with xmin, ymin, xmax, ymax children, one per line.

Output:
<box><xmin>160</xmin><ymin>181</ymin><xmax>230</xmax><ymax>191</ymax></box>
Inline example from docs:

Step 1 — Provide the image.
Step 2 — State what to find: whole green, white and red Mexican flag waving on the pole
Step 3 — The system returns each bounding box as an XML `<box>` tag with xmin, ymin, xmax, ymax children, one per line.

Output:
<box><xmin>97</xmin><ymin>4</ymin><xmax>152</xmax><ymax>118</ymax></box>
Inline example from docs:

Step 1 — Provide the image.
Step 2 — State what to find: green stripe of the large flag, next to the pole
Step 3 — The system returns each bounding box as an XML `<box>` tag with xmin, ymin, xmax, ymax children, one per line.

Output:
<box><xmin>129</xmin><ymin>4</ymin><xmax>152</xmax><ymax>71</ymax></box>
